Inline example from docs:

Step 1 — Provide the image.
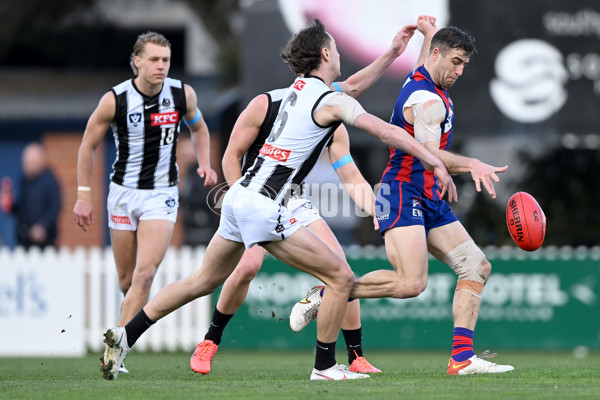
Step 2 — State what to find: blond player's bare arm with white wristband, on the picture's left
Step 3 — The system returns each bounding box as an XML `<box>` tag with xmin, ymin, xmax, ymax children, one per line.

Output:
<box><xmin>73</xmin><ymin>92</ymin><xmax>116</xmax><ymax>231</ymax></box>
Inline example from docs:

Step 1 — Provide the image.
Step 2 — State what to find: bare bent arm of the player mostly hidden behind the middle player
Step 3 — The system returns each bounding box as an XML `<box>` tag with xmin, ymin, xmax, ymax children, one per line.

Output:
<box><xmin>222</xmin><ymin>94</ymin><xmax>269</xmax><ymax>185</ymax></box>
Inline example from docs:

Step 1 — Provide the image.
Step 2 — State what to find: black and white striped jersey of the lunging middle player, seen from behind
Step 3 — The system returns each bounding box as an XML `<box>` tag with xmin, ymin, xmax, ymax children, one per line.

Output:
<box><xmin>240</xmin><ymin>76</ymin><xmax>341</xmax><ymax>202</ymax></box>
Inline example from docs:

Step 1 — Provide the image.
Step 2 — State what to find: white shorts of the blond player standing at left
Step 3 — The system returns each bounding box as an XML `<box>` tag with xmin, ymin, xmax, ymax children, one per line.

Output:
<box><xmin>107</xmin><ymin>182</ymin><xmax>179</xmax><ymax>231</ymax></box>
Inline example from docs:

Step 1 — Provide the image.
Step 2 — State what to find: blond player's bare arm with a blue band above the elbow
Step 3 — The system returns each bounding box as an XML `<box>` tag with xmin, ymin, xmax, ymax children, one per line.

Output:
<box><xmin>183</xmin><ymin>85</ymin><xmax>217</xmax><ymax>186</ymax></box>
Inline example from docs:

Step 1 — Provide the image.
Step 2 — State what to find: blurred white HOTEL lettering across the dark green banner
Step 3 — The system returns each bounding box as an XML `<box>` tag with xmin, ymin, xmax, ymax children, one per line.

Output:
<box><xmin>247</xmin><ymin>272</ymin><xmax>576</xmax><ymax>322</ymax></box>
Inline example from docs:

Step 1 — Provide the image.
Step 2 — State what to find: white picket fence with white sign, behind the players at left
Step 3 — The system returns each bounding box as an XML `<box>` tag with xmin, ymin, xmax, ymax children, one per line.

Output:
<box><xmin>0</xmin><ymin>247</ymin><xmax>212</xmax><ymax>356</ymax></box>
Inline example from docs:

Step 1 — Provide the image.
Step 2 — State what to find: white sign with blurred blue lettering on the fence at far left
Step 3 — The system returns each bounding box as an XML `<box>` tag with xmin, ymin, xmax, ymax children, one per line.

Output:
<box><xmin>0</xmin><ymin>255</ymin><xmax>89</xmax><ymax>357</ymax></box>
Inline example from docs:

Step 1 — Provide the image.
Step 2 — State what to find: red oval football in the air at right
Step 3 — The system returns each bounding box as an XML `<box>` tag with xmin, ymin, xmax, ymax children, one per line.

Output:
<box><xmin>506</xmin><ymin>192</ymin><xmax>546</xmax><ymax>251</ymax></box>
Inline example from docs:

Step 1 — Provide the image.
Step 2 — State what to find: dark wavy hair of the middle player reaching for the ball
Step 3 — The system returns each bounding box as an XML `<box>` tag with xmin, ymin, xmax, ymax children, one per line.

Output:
<box><xmin>280</xmin><ymin>18</ymin><xmax>331</xmax><ymax>75</ymax></box>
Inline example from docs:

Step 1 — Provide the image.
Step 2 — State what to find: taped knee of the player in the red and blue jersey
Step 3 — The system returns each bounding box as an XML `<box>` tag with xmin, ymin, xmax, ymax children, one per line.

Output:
<box><xmin>443</xmin><ymin>240</ymin><xmax>492</xmax><ymax>298</ymax></box>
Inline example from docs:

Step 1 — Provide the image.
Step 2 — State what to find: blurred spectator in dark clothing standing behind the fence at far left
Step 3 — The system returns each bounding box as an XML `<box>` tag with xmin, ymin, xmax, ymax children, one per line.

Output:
<box><xmin>0</xmin><ymin>143</ymin><xmax>61</xmax><ymax>248</ymax></box>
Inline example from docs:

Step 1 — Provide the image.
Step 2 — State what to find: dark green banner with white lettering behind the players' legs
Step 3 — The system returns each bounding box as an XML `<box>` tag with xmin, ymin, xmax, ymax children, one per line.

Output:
<box><xmin>214</xmin><ymin>250</ymin><xmax>600</xmax><ymax>351</ymax></box>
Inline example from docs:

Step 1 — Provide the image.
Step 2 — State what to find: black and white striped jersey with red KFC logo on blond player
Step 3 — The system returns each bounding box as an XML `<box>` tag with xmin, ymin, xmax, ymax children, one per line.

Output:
<box><xmin>110</xmin><ymin>78</ymin><xmax>187</xmax><ymax>189</ymax></box>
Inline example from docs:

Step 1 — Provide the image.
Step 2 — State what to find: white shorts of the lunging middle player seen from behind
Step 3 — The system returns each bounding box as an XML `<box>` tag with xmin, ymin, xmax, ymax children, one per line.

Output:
<box><xmin>217</xmin><ymin>183</ymin><xmax>308</xmax><ymax>249</ymax></box>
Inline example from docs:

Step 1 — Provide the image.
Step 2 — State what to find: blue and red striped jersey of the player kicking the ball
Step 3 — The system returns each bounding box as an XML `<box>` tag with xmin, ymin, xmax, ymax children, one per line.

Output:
<box><xmin>381</xmin><ymin>65</ymin><xmax>454</xmax><ymax>200</ymax></box>
